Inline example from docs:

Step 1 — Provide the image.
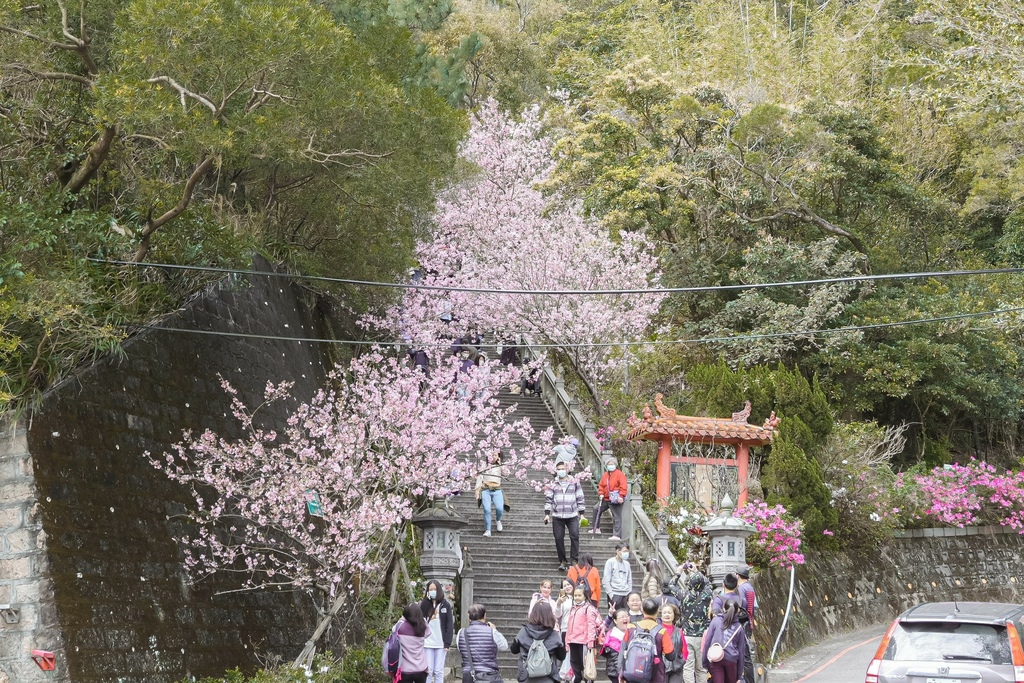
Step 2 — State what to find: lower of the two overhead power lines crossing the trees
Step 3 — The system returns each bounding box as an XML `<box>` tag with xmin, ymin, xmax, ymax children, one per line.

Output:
<box><xmin>126</xmin><ymin>306</ymin><xmax>1024</xmax><ymax>348</ymax></box>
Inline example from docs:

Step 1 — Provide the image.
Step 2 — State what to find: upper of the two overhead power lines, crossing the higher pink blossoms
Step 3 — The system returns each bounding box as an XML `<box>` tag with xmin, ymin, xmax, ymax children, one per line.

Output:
<box><xmin>89</xmin><ymin>258</ymin><xmax>1024</xmax><ymax>296</ymax></box>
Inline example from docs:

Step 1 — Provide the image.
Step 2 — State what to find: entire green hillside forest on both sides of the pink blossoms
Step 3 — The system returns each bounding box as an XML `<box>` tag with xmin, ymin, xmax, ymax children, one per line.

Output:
<box><xmin>0</xmin><ymin>0</ymin><xmax>1024</xmax><ymax>475</ymax></box>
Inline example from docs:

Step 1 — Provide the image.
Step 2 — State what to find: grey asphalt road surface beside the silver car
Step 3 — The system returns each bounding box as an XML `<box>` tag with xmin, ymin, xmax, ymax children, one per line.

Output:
<box><xmin>768</xmin><ymin>624</ymin><xmax>889</xmax><ymax>683</ymax></box>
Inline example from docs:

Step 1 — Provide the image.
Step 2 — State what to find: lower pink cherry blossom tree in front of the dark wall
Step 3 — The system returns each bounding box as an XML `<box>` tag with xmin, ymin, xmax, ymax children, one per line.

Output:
<box><xmin>147</xmin><ymin>350</ymin><xmax>551</xmax><ymax>658</ymax></box>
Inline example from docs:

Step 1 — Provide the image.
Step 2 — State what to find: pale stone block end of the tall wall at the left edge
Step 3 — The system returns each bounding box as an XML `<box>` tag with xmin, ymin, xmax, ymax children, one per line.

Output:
<box><xmin>0</xmin><ymin>420</ymin><xmax>68</xmax><ymax>683</ymax></box>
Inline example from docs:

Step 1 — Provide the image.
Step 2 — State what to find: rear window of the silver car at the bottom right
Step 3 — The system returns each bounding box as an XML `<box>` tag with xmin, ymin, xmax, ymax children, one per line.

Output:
<box><xmin>885</xmin><ymin>622</ymin><xmax>1012</xmax><ymax>665</ymax></box>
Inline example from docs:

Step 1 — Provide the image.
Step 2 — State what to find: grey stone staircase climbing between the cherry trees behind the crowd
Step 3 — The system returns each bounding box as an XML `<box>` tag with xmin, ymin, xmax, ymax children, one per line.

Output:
<box><xmin>449</xmin><ymin>391</ymin><xmax>643</xmax><ymax>683</ymax></box>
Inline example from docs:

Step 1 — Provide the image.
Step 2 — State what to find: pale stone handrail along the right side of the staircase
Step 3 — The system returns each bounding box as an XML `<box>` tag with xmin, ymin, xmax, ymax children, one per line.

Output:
<box><xmin>520</xmin><ymin>345</ymin><xmax>679</xmax><ymax>573</ymax></box>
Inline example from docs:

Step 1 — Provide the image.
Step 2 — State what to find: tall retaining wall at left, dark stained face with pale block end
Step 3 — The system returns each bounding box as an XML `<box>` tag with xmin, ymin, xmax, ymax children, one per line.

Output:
<box><xmin>0</xmin><ymin>259</ymin><xmax>328</xmax><ymax>683</ymax></box>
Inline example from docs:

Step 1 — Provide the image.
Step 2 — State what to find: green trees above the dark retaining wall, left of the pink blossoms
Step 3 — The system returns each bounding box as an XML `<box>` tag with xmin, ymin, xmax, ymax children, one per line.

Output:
<box><xmin>0</xmin><ymin>0</ymin><xmax>473</xmax><ymax>403</ymax></box>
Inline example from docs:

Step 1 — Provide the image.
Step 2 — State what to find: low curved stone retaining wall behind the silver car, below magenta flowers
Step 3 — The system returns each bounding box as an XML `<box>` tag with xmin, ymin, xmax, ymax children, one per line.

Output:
<box><xmin>754</xmin><ymin>526</ymin><xmax>1024</xmax><ymax>660</ymax></box>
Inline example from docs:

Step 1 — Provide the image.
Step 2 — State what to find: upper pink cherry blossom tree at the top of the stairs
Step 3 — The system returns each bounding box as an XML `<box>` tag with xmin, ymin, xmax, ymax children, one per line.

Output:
<box><xmin>390</xmin><ymin>100</ymin><xmax>663</xmax><ymax>407</ymax></box>
